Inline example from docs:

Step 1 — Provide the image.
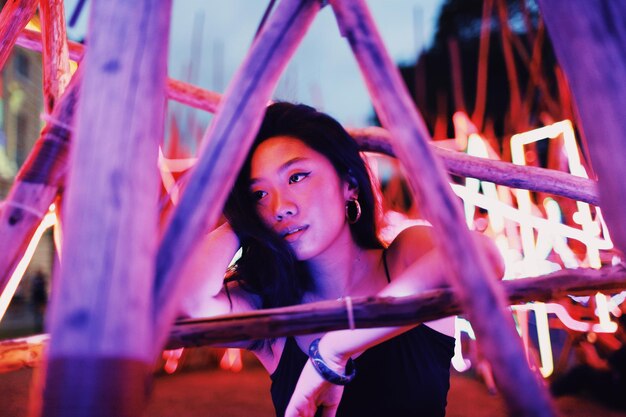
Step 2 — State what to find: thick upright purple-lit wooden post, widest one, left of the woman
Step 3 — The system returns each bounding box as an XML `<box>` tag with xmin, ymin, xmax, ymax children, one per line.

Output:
<box><xmin>43</xmin><ymin>0</ymin><xmax>171</xmax><ymax>416</ymax></box>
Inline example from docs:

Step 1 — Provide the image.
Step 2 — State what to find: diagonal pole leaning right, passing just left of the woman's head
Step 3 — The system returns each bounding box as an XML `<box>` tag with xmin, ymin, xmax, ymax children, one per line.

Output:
<box><xmin>154</xmin><ymin>0</ymin><xmax>320</xmax><ymax>350</ymax></box>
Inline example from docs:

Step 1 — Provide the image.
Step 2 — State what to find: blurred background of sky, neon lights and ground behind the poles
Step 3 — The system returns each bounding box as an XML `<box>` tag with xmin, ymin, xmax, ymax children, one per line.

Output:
<box><xmin>0</xmin><ymin>0</ymin><xmax>626</xmax><ymax>416</ymax></box>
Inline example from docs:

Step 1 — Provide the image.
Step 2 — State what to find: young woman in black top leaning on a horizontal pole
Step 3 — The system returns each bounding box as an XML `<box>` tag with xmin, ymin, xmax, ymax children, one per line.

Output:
<box><xmin>184</xmin><ymin>103</ymin><xmax>502</xmax><ymax>416</ymax></box>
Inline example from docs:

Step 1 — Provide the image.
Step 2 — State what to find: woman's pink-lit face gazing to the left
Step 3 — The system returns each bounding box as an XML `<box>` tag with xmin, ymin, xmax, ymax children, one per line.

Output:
<box><xmin>250</xmin><ymin>136</ymin><xmax>356</xmax><ymax>260</ymax></box>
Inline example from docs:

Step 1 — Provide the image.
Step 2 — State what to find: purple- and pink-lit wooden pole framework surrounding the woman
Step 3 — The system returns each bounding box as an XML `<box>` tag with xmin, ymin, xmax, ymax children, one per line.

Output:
<box><xmin>0</xmin><ymin>0</ymin><xmax>626</xmax><ymax>416</ymax></box>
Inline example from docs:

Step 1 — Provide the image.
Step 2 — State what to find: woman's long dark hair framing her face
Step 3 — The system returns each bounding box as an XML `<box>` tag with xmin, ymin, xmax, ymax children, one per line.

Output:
<box><xmin>224</xmin><ymin>102</ymin><xmax>383</xmax><ymax>308</ymax></box>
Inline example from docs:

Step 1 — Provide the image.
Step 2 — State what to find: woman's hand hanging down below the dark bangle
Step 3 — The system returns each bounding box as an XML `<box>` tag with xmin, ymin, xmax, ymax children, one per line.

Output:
<box><xmin>285</xmin><ymin>361</ymin><xmax>343</xmax><ymax>417</ymax></box>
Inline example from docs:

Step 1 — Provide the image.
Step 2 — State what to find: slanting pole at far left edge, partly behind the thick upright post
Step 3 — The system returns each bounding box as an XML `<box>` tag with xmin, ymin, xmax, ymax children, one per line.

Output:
<box><xmin>0</xmin><ymin>71</ymin><xmax>80</xmax><ymax>304</ymax></box>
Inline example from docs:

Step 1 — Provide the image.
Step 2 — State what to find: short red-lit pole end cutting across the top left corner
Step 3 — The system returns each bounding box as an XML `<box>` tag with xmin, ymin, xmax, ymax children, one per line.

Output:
<box><xmin>0</xmin><ymin>0</ymin><xmax>37</xmax><ymax>69</ymax></box>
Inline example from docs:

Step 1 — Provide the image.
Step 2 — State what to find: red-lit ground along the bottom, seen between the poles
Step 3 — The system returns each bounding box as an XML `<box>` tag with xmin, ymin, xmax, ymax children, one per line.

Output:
<box><xmin>0</xmin><ymin>366</ymin><xmax>626</xmax><ymax>417</ymax></box>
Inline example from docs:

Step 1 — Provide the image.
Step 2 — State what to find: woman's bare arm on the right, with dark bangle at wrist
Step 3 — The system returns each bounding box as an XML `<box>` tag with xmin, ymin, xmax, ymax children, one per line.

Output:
<box><xmin>285</xmin><ymin>228</ymin><xmax>504</xmax><ymax>417</ymax></box>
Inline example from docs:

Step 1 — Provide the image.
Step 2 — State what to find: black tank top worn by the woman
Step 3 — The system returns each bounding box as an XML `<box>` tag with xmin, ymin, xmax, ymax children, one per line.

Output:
<box><xmin>270</xmin><ymin>252</ymin><xmax>454</xmax><ymax>417</ymax></box>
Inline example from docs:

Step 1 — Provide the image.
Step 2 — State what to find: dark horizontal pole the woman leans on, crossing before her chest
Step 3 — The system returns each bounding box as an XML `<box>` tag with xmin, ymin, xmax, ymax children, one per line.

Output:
<box><xmin>167</xmin><ymin>264</ymin><xmax>626</xmax><ymax>349</ymax></box>
